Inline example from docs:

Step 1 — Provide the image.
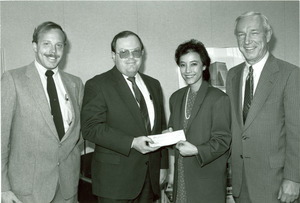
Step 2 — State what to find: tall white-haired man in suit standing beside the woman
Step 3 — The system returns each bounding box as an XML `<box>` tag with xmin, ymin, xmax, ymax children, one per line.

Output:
<box><xmin>226</xmin><ymin>12</ymin><xmax>300</xmax><ymax>203</ymax></box>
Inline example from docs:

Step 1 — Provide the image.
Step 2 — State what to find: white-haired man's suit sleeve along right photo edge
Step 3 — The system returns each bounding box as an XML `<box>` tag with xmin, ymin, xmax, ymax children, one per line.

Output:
<box><xmin>284</xmin><ymin>67</ymin><xmax>300</xmax><ymax>183</ymax></box>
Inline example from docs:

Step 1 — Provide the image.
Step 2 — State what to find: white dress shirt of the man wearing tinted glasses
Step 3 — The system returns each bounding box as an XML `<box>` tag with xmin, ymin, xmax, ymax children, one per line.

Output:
<box><xmin>123</xmin><ymin>73</ymin><xmax>155</xmax><ymax>129</ymax></box>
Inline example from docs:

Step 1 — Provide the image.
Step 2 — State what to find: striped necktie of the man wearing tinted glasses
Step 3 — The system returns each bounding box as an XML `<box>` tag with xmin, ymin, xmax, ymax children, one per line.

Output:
<box><xmin>127</xmin><ymin>77</ymin><xmax>151</xmax><ymax>134</ymax></box>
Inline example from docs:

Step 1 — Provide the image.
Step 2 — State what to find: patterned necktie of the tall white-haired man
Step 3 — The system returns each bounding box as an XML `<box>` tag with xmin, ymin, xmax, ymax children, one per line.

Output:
<box><xmin>243</xmin><ymin>66</ymin><xmax>253</xmax><ymax>123</ymax></box>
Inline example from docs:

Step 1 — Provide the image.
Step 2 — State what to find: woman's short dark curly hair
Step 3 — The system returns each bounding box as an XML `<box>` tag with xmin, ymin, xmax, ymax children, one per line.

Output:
<box><xmin>175</xmin><ymin>39</ymin><xmax>210</xmax><ymax>81</ymax></box>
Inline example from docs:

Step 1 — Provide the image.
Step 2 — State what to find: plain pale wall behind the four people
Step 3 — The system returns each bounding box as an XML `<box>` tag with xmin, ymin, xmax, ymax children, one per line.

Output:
<box><xmin>0</xmin><ymin>1</ymin><xmax>299</xmax><ymax>119</ymax></box>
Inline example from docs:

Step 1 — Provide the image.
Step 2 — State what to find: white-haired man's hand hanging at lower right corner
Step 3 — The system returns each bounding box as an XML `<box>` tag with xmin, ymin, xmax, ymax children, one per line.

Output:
<box><xmin>278</xmin><ymin>179</ymin><xmax>300</xmax><ymax>203</ymax></box>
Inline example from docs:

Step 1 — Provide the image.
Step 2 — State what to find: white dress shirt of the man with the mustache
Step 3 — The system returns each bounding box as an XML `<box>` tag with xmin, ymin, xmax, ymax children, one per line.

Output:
<box><xmin>35</xmin><ymin>61</ymin><xmax>72</xmax><ymax>132</ymax></box>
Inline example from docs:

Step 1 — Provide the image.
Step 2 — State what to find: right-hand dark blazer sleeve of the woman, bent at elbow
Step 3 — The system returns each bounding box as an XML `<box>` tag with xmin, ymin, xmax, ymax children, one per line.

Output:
<box><xmin>196</xmin><ymin>95</ymin><xmax>231</xmax><ymax>166</ymax></box>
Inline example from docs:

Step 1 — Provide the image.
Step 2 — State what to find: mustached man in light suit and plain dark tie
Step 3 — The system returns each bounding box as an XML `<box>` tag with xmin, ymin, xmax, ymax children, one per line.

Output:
<box><xmin>1</xmin><ymin>22</ymin><xmax>83</xmax><ymax>203</ymax></box>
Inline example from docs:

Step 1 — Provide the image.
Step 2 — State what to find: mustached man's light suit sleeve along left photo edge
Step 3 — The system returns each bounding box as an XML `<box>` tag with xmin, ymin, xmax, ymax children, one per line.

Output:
<box><xmin>1</xmin><ymin>72</ymin><xmax>17</xmax><ymax>192</ymax></box>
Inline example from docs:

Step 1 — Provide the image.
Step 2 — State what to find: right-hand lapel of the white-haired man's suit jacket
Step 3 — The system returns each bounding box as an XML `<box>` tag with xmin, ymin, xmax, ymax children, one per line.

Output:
<box><xmin>244</xmin><ymin>55</ymin><xmax>279</xmax><ymax>130</ymax></box>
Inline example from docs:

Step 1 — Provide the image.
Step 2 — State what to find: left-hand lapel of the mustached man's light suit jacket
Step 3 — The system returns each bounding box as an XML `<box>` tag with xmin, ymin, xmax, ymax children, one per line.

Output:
<box><xmin>25</xmin><ymin>62</ymin><xmax>58</xmax><ymax>139</ymax></box>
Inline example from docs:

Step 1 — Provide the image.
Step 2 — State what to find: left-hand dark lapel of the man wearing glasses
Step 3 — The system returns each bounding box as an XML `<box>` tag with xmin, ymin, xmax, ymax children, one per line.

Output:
<box><xmin>112</xmin><ymin>67</ymin><xmax>146</xmax><ymax>133</ymax></box>
